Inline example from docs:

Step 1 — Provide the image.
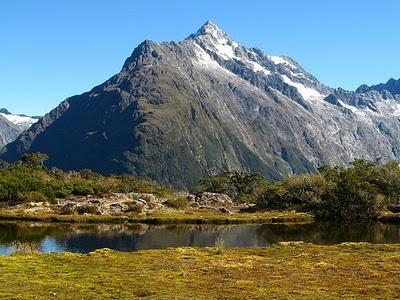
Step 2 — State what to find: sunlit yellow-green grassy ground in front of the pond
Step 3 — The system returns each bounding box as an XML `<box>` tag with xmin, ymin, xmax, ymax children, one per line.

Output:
<box><xmin>0</xmin><ymin>244</ymin><xmax>400</xmax><ymax>299</ymax></box>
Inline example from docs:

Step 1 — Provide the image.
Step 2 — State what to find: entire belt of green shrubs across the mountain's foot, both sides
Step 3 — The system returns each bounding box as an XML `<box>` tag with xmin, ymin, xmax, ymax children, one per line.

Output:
<box><xmin>0</xmin><ymin>153</ymin><xmax>400</xmax><ymax>220</ymax></box>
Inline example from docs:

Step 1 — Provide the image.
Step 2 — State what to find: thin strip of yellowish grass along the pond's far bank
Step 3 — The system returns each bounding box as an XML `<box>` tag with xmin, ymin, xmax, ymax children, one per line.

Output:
<box><xmin>0</xmin><ymin>210</ymin><xmax>313</xmax><ymax>224</ymax></box>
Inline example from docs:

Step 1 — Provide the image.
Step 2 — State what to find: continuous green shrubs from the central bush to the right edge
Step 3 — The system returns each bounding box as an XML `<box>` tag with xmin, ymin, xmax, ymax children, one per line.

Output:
<box><xmin>195</xmin><ymin>160</ymin><xmax>400</xmax><ymax>219</ymax></box>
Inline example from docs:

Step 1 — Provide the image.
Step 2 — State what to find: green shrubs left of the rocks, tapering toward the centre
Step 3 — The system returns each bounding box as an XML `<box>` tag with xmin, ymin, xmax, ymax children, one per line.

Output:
<box><xmin>0</xmin><ymin>153</ymin><xmax>174</xmax><ymax>203</ymax></box>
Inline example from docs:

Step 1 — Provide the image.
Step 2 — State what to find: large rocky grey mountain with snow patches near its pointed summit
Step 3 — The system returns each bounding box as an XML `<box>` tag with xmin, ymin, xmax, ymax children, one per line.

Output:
<box><xmin>0</xmin><ymin>22</ymin><xmax>400</xmax><ymax>187</ymax></box>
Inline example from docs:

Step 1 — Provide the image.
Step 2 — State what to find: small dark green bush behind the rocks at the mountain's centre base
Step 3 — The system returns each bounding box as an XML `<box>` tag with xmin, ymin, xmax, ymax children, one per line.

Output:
<box><xmin>194</xmin><ymin>171</ymin><xmax>267</xmax><ymax>202</ymax></box>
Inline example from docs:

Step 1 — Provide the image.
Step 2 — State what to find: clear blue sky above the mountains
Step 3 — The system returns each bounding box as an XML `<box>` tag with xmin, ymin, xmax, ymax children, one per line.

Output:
<box><xmin>0</xmin><ymin>0</ymin><xmax>400</xmax><ymax>115</ymax></box>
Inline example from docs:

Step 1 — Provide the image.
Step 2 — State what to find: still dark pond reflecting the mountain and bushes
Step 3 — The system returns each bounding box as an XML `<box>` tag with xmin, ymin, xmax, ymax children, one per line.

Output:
<box><xmin>0</xmin><ymin>222</ymin><xmax>400</xmax><ymax>255</ymax></box>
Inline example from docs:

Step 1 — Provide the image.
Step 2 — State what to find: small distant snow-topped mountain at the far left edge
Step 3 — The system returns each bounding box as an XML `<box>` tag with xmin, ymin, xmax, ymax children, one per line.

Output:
<box><xmin>0</xmin><ymin>108</ymin><xmax>39</xmax><ymax>148</ymax></box>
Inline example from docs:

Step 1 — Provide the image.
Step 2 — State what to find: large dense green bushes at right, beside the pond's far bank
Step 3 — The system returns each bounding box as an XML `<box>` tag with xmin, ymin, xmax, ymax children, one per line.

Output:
<box><xmin>257</xmin><ymin>160</ymin><xmax>400</xmax><ymax>219</ymax></box>
